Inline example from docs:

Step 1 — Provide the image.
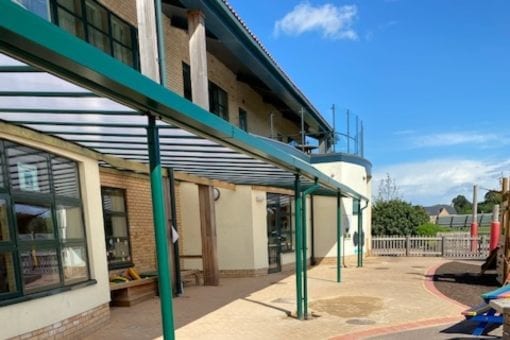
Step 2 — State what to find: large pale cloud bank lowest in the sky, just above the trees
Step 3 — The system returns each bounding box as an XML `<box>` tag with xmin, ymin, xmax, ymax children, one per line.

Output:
<box><xmin>372</xmin><ymin>159</ymin><xmax>510</xmax><ymax>205</ymax></box>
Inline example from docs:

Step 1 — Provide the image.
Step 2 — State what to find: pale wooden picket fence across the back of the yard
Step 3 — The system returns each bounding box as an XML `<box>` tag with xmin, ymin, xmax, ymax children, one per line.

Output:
<box><xmin>372</xmin><ymin>236</ymin><xmax>489</xmax><ymax>259</ymax></box>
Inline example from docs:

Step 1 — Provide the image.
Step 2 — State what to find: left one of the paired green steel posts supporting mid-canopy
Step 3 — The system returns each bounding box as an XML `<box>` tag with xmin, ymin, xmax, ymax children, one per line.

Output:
<box><xmin>294</xmin><ymin>175</ymin><xmax>303</xmax><ymax>320</ymax></box>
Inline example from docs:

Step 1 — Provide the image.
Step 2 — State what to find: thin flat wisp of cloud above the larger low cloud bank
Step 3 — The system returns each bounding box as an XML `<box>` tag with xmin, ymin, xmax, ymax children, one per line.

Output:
<box><xmin>413</xmin><ymin>131</ymin><xmax>502</xmax><ymax>147</ymax></box>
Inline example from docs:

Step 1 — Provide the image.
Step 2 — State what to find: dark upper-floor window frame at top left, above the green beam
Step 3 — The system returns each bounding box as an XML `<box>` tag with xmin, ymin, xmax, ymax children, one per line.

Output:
<box><xmin>48</xmin><ymin>0</ymin><xmax>140</xmax><ymax>71</ymax></box>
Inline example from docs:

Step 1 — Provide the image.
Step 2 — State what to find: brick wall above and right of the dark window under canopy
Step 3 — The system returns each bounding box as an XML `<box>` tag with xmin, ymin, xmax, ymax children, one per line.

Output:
<box><xmin>100</xmin><ymin>169</ymin><xmax>156</xmax><ymax>272</ymax></box>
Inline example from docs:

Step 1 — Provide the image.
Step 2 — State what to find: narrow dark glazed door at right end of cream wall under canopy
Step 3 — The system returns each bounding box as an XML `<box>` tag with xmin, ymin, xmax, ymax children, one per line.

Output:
<box><xmin>267</xmin><ymin>193</ymin><xmax>282</xmax><ymax>273</ymax></box>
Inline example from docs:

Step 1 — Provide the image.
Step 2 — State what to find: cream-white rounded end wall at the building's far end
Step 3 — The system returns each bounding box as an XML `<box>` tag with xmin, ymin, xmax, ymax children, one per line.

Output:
<box><xmin>314</xmin><ymin>162</ymin><xmax>372</xmax><ymax>258</ymax></box>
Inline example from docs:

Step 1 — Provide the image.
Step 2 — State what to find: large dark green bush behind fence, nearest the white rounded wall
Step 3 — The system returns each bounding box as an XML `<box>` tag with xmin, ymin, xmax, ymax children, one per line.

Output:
<box><xmin>372</xmin><ymin>199</ymin><xmax>429</xmax><ymax>236</ymax></box>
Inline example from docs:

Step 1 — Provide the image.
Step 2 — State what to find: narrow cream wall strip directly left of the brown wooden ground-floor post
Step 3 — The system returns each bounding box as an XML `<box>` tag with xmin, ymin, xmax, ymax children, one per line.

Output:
<box><xmin>179</xmin><ymin>182</ymin><xmax>203</xmax><ymax>270</ymax></box>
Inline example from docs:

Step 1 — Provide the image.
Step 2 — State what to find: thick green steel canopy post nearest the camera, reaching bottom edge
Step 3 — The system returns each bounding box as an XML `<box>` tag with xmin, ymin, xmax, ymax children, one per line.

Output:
<box><xmin>147</xmin><ymin>115</ymin><xmax>175</xmax><ymax>340</ymax></box>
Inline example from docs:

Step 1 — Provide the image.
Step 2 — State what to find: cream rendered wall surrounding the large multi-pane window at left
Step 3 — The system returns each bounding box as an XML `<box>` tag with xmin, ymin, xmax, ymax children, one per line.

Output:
<box><xmin>0</xmin><ymin>130</ymin><xmax>110</xmax><ymax>338</ymax></box>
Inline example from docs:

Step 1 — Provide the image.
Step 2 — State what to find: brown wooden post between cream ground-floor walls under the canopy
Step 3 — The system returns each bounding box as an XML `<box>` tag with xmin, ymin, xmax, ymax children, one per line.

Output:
<box><xmin>198</xmin><ymin>185</ymin><xmax>220</xmax><ymax>286</ymax></box>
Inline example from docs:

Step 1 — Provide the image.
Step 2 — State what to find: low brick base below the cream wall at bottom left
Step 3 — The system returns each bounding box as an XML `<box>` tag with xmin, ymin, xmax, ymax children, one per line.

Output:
<box><xmin>11</xmin><ymin>303</ymin><xmax>110</xmax><ymax>340</ymax></box>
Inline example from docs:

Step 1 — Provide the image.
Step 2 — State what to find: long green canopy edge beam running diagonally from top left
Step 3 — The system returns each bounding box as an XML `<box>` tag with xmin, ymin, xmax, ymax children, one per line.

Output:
<box><xmin>0</xmin><ymin>0</ymin><xmax>368</xmax><ymax>200</ymax></box>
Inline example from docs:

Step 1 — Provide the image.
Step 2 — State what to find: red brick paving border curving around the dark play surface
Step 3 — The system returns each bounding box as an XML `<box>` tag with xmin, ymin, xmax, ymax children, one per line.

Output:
<box><xmin>330</xmin><ymin>261</ymin><xmax>469</xmax><ymax>340</ymax></box>
